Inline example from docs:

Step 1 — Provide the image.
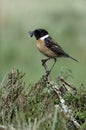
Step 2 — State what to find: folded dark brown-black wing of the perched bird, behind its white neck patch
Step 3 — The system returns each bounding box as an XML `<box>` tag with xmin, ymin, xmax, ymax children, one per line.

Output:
<box><xmin>45</xmin><ymin>37</ymin><xmax>70</xmax><ymax>57</ymax></box>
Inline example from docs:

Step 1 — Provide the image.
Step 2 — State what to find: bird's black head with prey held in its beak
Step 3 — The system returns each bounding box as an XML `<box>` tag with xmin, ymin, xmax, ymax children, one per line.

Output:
<box><xmin>29</xmin><ymin>28</ymin><xmax>48</xmax><ymax>40</ymax></box>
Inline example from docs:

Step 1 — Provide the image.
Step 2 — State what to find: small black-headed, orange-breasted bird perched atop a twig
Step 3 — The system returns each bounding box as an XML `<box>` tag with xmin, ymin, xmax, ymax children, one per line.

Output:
<box><xmin>29</xmin><ymin>28</ymin><xmax>78</xmax><ymax>74</ymax></box>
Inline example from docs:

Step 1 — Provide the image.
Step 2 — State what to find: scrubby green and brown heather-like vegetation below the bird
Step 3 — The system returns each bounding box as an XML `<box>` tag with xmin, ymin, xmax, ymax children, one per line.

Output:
<box><xmin>0</xmin><ymin>70</ymin><xmax>86</xmax><ymax>130</ymax></box>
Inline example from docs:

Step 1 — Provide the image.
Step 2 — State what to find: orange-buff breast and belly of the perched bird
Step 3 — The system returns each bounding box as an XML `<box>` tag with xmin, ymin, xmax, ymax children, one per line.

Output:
<box><xmin>37</xmin><ymin>39</ymin><xmax>57</xmax><ymax>57</ymax></box>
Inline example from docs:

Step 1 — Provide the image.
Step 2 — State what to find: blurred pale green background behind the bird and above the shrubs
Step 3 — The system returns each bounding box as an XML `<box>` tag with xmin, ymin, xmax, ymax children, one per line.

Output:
<box><xmin>0</xmin><ymin>0</ymin><xmax>86</xmax><ymax>86</ymax></box>
